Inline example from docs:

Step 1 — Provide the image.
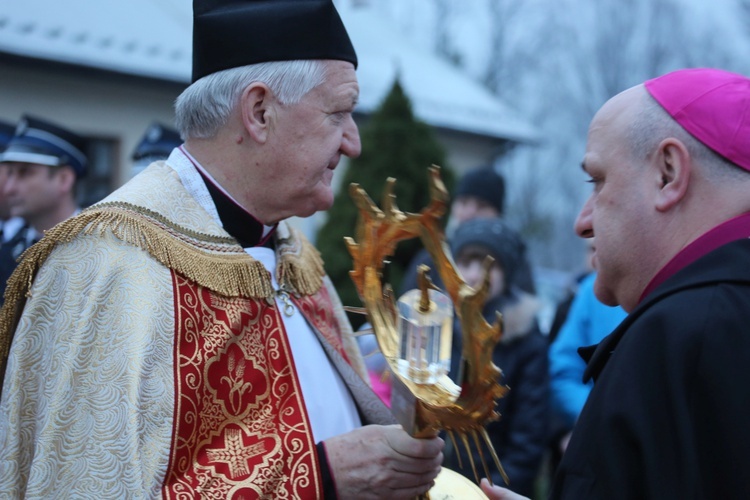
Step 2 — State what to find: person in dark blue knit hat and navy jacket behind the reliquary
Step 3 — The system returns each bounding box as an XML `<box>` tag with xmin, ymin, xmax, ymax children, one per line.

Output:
<box><xmin>446</xmin><ymin>218</ymin><xmax>549</xmax><ymax>496</ymax></box>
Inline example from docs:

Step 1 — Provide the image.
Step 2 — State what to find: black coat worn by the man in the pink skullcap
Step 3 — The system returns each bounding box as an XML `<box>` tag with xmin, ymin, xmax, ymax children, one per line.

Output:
<box><xmin>551</xmin><ymin>239</ymin><xmax>750</xmax><ymax>500</ymax></box>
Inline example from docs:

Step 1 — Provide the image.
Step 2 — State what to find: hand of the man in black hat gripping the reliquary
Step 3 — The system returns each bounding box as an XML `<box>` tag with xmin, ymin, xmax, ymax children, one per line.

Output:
<box><xmin>325</xmin><ymin>425</ymin><xmax>445</xmax><ymax>500</ymax></box>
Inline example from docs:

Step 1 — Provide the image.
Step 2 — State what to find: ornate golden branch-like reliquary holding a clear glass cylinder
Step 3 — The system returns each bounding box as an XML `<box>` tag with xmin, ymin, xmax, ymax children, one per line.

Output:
<box><xmin>345</xmin><ymin>165</ymin><xmax>507</xmax><ymax>500</ymax></box>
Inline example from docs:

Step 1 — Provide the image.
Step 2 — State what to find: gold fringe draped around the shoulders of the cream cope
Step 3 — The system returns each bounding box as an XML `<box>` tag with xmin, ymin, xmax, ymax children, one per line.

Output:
<box><xmin>0</xmin><ymin>204</ymin><xmax>324</xmax><ymax>374</ymax></box>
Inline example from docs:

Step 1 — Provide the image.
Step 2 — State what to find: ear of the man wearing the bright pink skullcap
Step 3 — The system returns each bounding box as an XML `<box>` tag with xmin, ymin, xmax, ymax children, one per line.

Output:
<box><xmin>653</xmin><ymin>137</ymin><xmax>694</xmax><ymax>212</ymax></box>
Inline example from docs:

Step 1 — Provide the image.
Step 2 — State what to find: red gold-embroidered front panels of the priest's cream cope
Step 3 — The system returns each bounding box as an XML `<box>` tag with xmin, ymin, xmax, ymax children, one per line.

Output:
<box><xmin>162</xmin><ymin>272</ymin><xmax>352</xmax><ymax>499</ymax></box>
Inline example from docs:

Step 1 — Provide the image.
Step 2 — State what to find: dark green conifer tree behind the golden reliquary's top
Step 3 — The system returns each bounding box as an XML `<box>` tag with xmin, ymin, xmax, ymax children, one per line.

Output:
<box><xmin>317</xmin><ymin>79</ymin><xmax>455</xmax><ymax>328</ymax></box>
